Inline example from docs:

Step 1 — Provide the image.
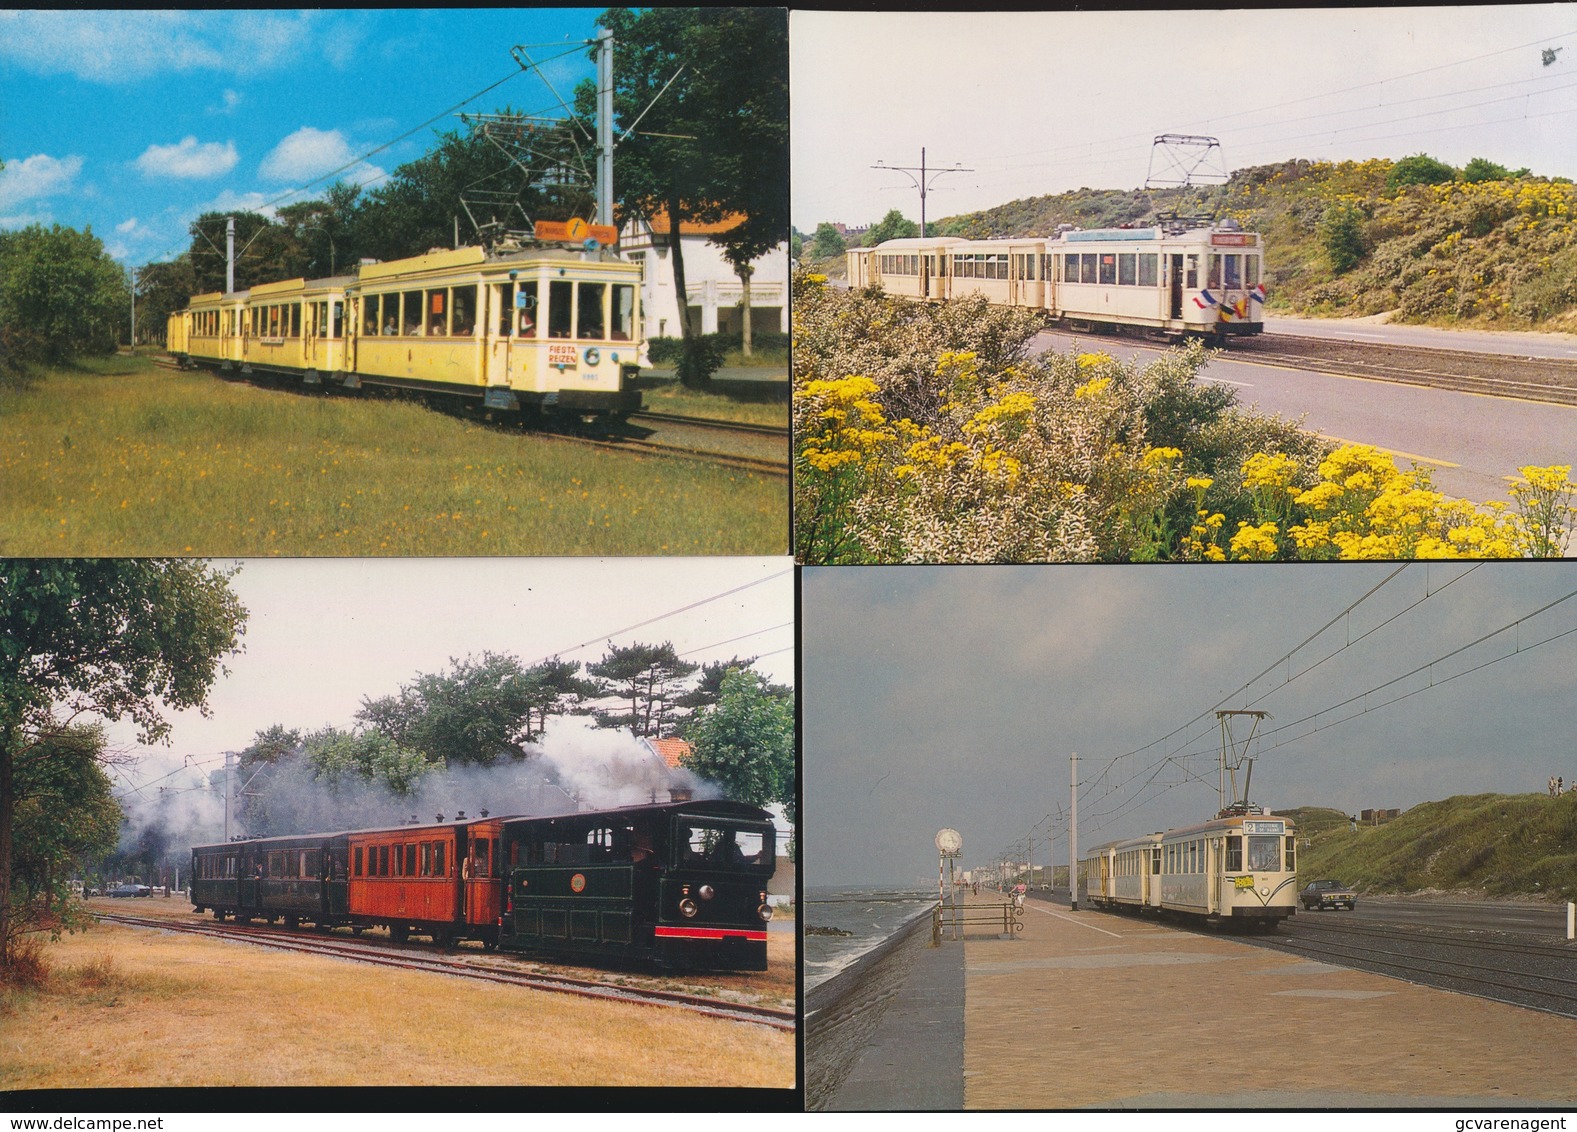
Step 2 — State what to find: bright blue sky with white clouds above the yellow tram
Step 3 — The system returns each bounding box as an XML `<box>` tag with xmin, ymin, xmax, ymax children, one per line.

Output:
<box><xmin>0</xmin><ymin>8</ymin><xmax>602</xmax><ymax>265</ymax></box>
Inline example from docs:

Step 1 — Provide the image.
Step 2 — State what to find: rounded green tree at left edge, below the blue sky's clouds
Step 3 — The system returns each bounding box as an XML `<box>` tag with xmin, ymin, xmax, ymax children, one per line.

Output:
<box><xmin>0</xmin><ymin>224</ymin><xmax>131</xmax><ymax>363</ymax></box>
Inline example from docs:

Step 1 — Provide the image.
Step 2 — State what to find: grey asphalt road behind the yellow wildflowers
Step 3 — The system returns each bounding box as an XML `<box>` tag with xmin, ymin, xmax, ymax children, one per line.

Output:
<box><xmin>1036</xmin><ymin>322</ymin><xmax>1577</xmax><ymax>503</ymax></box>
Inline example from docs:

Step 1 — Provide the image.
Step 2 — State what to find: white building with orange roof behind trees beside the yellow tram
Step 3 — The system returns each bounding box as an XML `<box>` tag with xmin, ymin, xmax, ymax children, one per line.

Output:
<box><xmin>620</xmin><ymin>213</ymin><xmax>789</xmax><ymax>337</ymax></box>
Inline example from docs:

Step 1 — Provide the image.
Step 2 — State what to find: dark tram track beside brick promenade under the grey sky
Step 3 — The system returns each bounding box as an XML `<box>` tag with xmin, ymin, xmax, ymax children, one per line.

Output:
<box><xmin>1246</xmin><ymin>922</ymin><xmax>1577</xmax><ymax>1017</ymax></box>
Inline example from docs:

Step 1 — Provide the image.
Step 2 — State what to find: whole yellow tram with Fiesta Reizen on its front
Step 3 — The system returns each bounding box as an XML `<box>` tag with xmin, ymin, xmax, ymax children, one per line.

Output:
<box><xmin>167</xmin><ymin>246</ymin><xmax>643</xmax><ymax>421</ymax></box>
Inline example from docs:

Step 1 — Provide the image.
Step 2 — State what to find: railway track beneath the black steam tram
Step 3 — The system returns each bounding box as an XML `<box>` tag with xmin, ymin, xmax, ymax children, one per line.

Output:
<box><xmin>95</xmin><ymin>913</ymin><xmax>795</xmax><ymax>1031</ymax></box>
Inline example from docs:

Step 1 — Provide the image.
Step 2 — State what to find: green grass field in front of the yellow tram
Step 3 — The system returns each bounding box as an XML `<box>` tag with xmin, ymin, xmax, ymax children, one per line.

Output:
<box><xmin>0</xmin><ymin>358</ymin><xmax>789</xmax><ymax>557</ymax></box>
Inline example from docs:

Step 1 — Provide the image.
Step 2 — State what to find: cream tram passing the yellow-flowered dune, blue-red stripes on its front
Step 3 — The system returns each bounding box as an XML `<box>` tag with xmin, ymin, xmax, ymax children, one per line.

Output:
<box><xmin>848</xmin><ymin>219</ymin><xmax>1265</xmax><ymax>342</ymax></box>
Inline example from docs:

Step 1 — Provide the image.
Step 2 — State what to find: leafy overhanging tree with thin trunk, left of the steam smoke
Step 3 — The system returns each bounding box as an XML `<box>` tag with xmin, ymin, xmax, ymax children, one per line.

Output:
<box><xmin>0</xmin><ymin>558</ymin><xmax>246</xmax><ymax>966</ymax></box>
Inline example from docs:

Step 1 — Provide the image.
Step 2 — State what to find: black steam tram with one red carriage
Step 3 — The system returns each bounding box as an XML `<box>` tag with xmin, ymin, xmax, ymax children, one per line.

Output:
<box><xmin>191</xmin><ymin>801</ymin><xmax>776</xmax><ymax>971</ymax></box>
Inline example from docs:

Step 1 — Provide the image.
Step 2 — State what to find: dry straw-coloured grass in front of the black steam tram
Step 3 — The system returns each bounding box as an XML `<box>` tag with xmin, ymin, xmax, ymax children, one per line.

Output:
<box><xmin>0</xmin><ymin>920</ymin><xmax>795</xmax><ymax>1089</ymax></box>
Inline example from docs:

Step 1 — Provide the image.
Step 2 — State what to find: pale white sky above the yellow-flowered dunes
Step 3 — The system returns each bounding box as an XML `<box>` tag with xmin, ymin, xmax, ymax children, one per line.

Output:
<box><xmin>790</xmin><ymin>3</ymin><xmax>1577</xmax><ymax>232</ymax></box>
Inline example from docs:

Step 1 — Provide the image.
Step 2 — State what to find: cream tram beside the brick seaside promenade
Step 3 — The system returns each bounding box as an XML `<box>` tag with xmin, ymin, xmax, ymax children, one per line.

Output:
<box><xmin>1083</xmin><ymin>814</ymin><xmax>1298</xmax><ymax>929</ymax></box>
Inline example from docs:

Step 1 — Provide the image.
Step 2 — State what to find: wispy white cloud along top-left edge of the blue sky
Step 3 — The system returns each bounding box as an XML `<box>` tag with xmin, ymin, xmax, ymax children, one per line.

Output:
<box><xmin>0</xmin><ymin>9</ymin><xmax>323</xmax><ymax>84</ymax></box>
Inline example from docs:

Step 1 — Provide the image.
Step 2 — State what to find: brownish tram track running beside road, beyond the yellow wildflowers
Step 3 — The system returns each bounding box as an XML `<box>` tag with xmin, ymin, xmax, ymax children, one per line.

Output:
<box><xmin>1227</xmin><ymin>334</ymin><xmax>1577</xmax><ymax>405</ymax></box>
